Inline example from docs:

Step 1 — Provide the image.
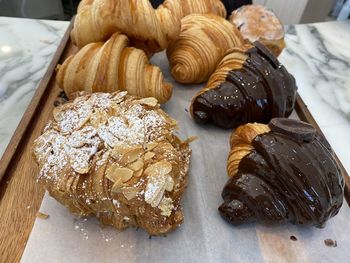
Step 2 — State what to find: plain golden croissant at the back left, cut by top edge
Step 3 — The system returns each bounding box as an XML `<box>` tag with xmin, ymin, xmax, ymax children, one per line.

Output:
<box><xmin>71</xmin><ymin>0</ymin><xmax>180</xmax><ymax>52</ymax></box>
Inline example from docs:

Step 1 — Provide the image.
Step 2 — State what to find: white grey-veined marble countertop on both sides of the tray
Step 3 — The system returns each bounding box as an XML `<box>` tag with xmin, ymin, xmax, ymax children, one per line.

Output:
<box><xmin>0</xmin><ymin>17</ymin><xmax>350</xmax><ymax>172</ymax></box>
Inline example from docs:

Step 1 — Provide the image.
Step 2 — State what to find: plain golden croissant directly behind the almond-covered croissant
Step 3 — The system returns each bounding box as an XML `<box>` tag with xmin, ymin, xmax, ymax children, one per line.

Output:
<box><xmin>56</xmin><ymin>33</ymin><xmax>172</xmax><ymax>103</ymax></box>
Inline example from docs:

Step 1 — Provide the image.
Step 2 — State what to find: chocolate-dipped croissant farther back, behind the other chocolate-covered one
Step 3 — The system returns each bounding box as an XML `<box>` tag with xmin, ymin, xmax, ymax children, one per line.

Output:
<box><xmin>190</xmin><ymin>42</ymin><xmax>297</xmax><ymax>128</ymax></box>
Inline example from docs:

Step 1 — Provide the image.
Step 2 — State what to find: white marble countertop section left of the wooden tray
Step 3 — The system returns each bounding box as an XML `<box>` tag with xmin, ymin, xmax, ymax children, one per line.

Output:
<box><xmin>0</xmin><ymin>17</ymin><xmax>69</xmax><ymax>157</ymax></box>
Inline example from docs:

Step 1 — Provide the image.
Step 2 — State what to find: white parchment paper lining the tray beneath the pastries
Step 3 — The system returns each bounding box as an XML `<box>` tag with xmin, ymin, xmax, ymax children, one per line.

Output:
<box><xmin>22</xmin><ymin>53</ymin><xmax>350</xmax><ymax>262</ymax></box>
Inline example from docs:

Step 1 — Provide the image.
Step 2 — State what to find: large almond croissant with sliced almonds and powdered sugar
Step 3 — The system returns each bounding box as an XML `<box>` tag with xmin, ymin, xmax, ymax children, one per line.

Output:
<box><xmin>33</xmin><ymin>91</ymin><xmax>191</xmax><ymax>235</ymax></box>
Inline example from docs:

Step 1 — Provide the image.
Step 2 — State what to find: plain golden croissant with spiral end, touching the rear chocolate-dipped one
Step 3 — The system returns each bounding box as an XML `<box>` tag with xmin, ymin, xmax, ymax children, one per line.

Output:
<box><xmin>167</xmin><ymin>14</ymin><xmax>243</xmax><ymax>84</ymax></box>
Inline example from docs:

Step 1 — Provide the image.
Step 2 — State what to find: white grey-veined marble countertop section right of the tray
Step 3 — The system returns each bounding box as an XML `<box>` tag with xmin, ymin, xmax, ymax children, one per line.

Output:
<box><xmin>280</xmin><ymin>20</ymin><xmax>350</xmax><ymax>173</ymax></box>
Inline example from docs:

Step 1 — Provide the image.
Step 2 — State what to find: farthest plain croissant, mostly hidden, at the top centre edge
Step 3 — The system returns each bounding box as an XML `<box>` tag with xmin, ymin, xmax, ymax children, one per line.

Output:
<box><xmin>160</xmin><ymin>0</ymin><xmax>226</xmax><ymax>19</ymax></box>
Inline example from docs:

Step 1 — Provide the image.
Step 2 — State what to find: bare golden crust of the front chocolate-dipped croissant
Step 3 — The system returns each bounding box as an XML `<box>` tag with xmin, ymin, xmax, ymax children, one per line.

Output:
<box><xmin>227</xmin><ymin>123</ymin><xmax>270</xmax><ymax>177</ymax></box>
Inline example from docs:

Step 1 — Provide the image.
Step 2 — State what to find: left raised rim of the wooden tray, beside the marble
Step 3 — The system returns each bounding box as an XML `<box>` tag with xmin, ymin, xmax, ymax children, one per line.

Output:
<box><xmin>0</xmin><ymin>18</ymin><xmax>74</xmax><ymax>183</ymax></box>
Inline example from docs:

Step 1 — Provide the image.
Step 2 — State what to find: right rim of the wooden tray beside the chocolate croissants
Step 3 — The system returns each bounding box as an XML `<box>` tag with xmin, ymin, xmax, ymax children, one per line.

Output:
<box><xmin>295</xmin><ymin>93</ymin><xmax>350</xmax><ymax>206</ymax></box>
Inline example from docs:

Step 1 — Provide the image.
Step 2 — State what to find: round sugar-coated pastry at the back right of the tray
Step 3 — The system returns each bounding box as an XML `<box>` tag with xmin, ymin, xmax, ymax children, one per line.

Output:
<box><xmin>229</xmin><ymin>5</ymin><xmax>285</xmax><ymax>57</ymax></box>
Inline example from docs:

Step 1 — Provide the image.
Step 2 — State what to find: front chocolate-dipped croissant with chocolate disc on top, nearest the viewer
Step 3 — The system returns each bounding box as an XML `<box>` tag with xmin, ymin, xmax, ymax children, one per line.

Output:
<box><xmin>219</xmin><ymin>118</ymin><xmax>344</xmax><ymax>227</ymax></box>
